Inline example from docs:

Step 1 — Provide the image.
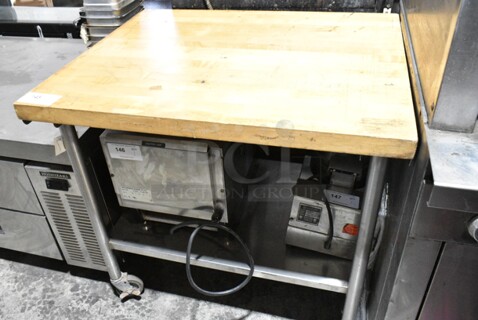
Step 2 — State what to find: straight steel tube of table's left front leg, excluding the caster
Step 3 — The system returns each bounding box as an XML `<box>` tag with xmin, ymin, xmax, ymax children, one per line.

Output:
<box><xmin>60</xmin><ymin>125</ymin><xmax>122</xmax><ymax>280</ymax></box>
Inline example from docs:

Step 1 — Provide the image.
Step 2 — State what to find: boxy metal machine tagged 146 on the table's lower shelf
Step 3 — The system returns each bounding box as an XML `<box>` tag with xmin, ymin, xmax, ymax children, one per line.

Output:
<box><xmin>101</xmin><ymin>131</ymin><xmax>228</xmax><ymax>223</ymax></box>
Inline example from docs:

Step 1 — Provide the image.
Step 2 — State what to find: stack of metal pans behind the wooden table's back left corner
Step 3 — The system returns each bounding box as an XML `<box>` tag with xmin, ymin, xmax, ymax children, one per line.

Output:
<box><xmin>81</xmin><ymin>0</ymin><xmax>143</xmax><ymax>45</ymax></box>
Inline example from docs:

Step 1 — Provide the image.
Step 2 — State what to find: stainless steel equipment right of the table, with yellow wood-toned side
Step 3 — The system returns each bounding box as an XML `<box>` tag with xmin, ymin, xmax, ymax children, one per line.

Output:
<box><xmin>369</xmin><ymin>0</ymin><xmax>478</xmax><ymax>320</ymax></box>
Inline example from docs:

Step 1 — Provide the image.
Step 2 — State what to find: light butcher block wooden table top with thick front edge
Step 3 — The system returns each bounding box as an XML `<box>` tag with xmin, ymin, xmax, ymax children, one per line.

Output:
<box><xmin>15</xmin><ymin>10</ymin><xmax>417</xmax><ymax>158</ymax></box>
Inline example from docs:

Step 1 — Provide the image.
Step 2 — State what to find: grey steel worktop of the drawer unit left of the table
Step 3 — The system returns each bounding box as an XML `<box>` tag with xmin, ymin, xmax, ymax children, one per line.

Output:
<box><xmin>0</xmin><ymin>37</ymin><xmax>86</xmax><ymax>165</ymax></box>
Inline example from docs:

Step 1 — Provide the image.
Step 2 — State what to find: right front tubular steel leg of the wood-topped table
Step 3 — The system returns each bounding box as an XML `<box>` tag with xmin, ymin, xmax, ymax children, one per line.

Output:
<box><xmin>342</xmin><ymin>157</ymin><xmax>387</xmax><ymax>320</ymax></box>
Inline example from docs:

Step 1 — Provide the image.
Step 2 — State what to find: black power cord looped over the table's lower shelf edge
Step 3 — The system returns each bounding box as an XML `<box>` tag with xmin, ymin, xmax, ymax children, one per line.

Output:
<box><xmin>170</xmin><ymin>220</ymin><xmax>254</xmax><ymax>297</ymax></box>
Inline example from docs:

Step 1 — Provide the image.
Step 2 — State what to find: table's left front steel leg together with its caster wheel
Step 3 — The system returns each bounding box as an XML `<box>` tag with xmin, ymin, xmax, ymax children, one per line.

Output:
<box><xmin>60</xmin><ymin>125</ymin><xmax>143</xmax><ymax>299</ymax></box>
